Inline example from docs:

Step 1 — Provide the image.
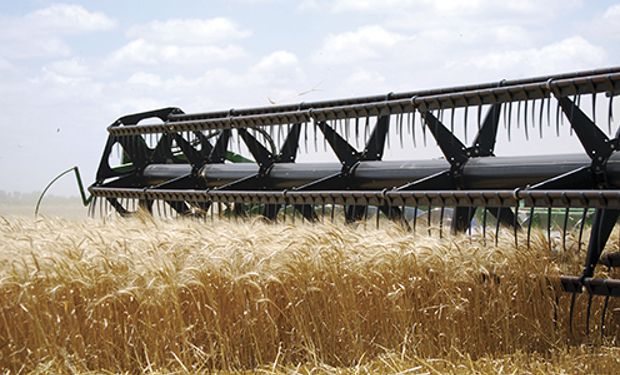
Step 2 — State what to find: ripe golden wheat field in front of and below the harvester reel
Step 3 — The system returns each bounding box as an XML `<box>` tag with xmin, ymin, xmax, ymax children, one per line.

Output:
<box><xmin>0</xmin><ymin>217</ymin><xmax>620</xmax><ymax>374</ymax></box>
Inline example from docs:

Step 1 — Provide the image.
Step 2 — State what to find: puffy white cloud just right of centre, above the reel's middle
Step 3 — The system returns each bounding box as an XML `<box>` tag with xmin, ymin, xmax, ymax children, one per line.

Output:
<box><xmin>313</xmin><ymin>25</ymin><xmax>406</xmax><ymax>64</ymax></box>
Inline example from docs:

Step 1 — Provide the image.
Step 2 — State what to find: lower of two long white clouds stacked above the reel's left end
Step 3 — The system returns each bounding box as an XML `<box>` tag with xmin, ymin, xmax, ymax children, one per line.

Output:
<box><xmin>109</xmin><ymin>39</ymin><xmax>244</xmax><ymax>65</ymax></box>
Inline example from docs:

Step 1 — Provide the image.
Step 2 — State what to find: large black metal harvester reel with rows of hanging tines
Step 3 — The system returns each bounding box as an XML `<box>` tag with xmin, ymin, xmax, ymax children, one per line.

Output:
<box><xmin>89</xmin><ymin>68</ymin><xmax>620</xmax><ymax>336</ymax></box>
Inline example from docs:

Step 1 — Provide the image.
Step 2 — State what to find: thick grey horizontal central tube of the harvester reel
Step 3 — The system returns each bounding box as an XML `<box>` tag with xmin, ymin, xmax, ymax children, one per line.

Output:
<box><xmin>137</xmin><ymin>154</ymin><xmax>620</xmax><ymax>190</ymax></box>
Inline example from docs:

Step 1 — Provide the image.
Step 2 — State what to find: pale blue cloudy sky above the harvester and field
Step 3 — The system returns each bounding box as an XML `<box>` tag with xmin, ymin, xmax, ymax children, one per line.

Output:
<box><xmin>0</xmin><ymin>0</ymin><xmax>620</xmax><ymax>194</ymax></box>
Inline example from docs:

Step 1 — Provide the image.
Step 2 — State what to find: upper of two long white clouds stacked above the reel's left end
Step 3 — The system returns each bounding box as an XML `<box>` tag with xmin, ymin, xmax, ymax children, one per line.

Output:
<box><xmin>127</xmin><ymin>17</ymin><xmax>251</xmax><ymax>45</ymax></box>
